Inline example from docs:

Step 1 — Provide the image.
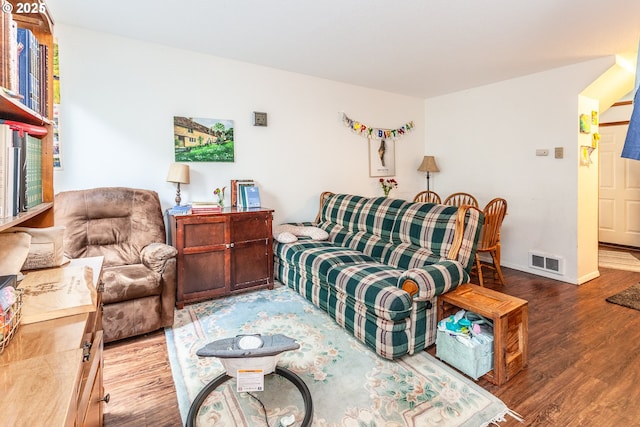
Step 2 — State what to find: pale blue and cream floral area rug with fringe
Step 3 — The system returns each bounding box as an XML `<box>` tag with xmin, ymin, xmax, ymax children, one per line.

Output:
<box><xmin>166</xmin><ymin>284</ymin><xmax>517</xmax><ymax>427</ymax></box>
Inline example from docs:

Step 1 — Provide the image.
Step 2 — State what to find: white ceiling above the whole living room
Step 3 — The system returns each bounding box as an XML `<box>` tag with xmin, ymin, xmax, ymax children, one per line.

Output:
<box><xmin>47</xmin><ymin>0</ymin><xmax>640</xmax><ymax>98</ymax></box>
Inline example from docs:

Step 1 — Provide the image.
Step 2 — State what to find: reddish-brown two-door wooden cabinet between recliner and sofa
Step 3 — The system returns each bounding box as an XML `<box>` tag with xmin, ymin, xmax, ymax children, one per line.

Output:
<box><xmin>169</xmin><ymin>208</ymin><xmax>273</xmax><ymax>308</ymax></box>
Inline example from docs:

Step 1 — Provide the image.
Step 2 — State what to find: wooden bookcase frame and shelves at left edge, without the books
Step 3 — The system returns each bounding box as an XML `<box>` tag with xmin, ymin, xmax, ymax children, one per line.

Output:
<box><xmin>0</xmin><ymin>0</ymin><xmax>54</xmax><ymax>231</ymax></box>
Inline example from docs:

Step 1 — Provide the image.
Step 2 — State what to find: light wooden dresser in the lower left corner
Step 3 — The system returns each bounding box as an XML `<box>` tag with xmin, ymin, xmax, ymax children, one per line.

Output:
<box><xmin>0</xmin><ymin>257</ymin><xmax>108</xmax><ymax>427</ymax></box>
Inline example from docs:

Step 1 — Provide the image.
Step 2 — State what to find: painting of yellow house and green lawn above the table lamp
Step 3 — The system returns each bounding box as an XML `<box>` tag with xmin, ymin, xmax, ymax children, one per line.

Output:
<box><xmin>173</xmin><ymin>116</ymin><xmax>235</xmax><ymax>162</ymax></box>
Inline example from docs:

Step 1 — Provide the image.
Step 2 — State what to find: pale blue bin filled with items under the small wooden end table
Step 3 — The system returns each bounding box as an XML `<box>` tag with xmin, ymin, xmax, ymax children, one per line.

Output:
<box><xmin>436</xmin><ymin>310</ymin><xmax>493</xmax><ymax>380</ymax></box>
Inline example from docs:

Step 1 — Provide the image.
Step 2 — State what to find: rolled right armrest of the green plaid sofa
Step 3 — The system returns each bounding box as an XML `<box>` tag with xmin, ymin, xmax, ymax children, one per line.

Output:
<box><xmin>398</xmin><ymin>260</ymin><xmax>469</xmax><ymax>301</ymax></box>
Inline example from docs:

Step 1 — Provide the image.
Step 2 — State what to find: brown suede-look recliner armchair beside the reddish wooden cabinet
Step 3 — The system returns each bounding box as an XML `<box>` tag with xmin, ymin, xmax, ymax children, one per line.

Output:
<box><xmin>54</xmin><ymin>187</ymin><xmax>177</xmax><ymax>342</ymax></box>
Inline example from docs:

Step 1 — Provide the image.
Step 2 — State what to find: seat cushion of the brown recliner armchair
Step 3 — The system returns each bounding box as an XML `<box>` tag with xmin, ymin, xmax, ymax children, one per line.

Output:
<box><xmin>102</xmin><ymin>264</ymin><xmax>162</xmax><ymax>304</ymax></box>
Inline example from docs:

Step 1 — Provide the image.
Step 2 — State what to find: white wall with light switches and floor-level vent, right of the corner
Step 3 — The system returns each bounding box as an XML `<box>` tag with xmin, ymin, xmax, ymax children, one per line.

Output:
<box><xmin>425</xmin><ymin>58</ymin><xmax>615</xmax><ymax>283</ymax></box>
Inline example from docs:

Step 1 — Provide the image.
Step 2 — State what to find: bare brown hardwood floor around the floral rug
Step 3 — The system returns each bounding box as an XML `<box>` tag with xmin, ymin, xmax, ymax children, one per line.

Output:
<box><xmin>104</xmin><ymin>262</ymin><xmax>640</xmax><ymax>427</ymax></box>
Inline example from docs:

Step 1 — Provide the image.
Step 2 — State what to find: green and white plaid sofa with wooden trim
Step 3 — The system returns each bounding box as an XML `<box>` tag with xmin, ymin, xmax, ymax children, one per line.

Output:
<box><xmin>274</xmin><ymin>193</ymin><xmax>483</xmax><ymax>359</ymax></box>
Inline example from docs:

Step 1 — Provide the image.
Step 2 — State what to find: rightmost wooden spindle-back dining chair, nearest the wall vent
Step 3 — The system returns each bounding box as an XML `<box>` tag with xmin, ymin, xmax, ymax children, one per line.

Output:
<box><xmin>475</xmin><ymin>197</ymin><xmax>507</xmax><ymax>286</ymax></box>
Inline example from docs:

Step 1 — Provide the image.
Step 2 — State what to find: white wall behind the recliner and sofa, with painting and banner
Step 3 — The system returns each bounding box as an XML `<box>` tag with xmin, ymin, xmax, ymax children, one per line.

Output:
<box><xmin>54</xmin><ymin>25</ymin><xmax>424</xmax><ymax>223</ymax></box>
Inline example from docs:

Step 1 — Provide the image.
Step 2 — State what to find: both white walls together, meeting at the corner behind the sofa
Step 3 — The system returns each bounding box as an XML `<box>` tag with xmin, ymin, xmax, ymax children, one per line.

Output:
<box><xmin>54</xmin><ymin>25</ymin><xmax>614</xmax><ymax>283</ymax></box>
